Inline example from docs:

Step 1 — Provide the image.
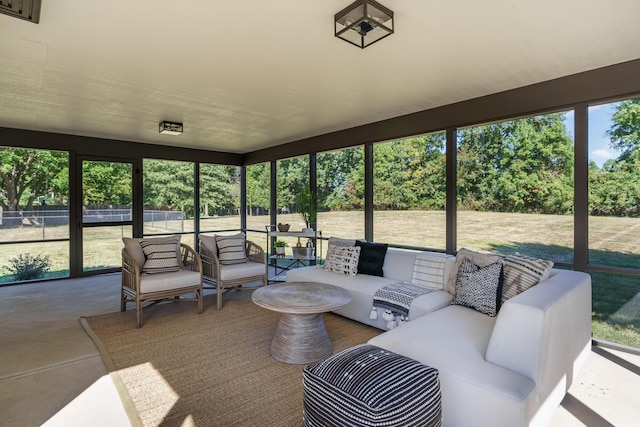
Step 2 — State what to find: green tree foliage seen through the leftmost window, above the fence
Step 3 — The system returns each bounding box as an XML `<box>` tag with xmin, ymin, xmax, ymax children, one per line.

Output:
<box><xmin>0</xmin><ymin>147</ymin><xmax>69</xmax><ymax>211</ymax></box>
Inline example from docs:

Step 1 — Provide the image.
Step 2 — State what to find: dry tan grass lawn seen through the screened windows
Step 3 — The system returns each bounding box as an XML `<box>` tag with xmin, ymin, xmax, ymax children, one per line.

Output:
<box><xmin>0</xmin><ymin>211</ymin><xmax>640</xmax><ymax>347</ymax></box>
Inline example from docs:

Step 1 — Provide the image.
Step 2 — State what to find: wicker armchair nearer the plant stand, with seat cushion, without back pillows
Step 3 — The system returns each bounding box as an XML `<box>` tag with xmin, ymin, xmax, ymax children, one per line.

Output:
<box><xmin>200</xmin><ymin>239</ymin><xmax>267</xmax><ymax>310</ymax></box>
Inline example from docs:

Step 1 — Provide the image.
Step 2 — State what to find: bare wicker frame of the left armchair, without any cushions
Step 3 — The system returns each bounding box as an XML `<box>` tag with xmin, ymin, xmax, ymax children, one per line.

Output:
<box><xmin>120</xmin><ymin>243</ymin><xmax>203</xmax><ymax>328</ymax></box>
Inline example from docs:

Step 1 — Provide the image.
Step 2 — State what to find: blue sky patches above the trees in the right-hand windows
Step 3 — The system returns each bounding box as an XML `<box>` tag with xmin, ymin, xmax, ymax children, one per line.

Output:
<box><xmin>565</xmin><ymin>104</ymin><xmax>620</xmax><ymax>167</ymax></box>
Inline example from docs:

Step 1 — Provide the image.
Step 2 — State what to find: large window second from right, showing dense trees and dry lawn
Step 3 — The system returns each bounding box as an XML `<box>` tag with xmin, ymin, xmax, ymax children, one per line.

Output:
<box><xmin>457</xmin><ymin>113</ymin><xmax>574</xmax><ymax>264</ymax></box>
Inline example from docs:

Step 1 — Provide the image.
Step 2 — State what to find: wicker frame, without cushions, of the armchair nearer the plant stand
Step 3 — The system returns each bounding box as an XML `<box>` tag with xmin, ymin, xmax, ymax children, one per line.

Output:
<box><xmin>200</xmin><ymin>240</ymin><xmax>268</xmax><ymax>310</ymax></box>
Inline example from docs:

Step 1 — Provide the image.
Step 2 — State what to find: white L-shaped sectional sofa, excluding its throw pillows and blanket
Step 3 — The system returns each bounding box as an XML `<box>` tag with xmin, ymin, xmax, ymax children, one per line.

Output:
<box><xmin>287</xmin><ymin>250</ymin><xmax>591</xmax><ymax>427</ymax></box>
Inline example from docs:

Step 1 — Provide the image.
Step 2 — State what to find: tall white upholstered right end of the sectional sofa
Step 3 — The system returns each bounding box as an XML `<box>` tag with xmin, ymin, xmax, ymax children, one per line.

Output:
<box><xmin>486</xmin><ymin>270</ymin><xmax>591</xmax><ymax>399</ymax></box>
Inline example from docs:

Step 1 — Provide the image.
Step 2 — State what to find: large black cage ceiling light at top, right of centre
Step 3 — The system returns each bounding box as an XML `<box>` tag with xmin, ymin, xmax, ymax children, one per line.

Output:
<box><xmin>335</xmin><ymin>0</ymin><xmax>393</xmax><ymax>49</ymax></box>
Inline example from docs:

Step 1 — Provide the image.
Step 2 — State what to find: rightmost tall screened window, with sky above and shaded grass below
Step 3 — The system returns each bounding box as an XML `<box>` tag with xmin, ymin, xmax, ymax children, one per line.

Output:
<box><xmin>588</xmin><ymin>99</ymin><xmax>640</xmax><ymax>347</ymax></box>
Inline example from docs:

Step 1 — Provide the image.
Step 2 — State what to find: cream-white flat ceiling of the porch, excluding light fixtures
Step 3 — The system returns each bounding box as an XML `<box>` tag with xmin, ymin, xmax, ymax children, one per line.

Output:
<box><xmin>0</xmin><ymin>0</ymin><xmax>640</xmax><ymax>153</ymax></box>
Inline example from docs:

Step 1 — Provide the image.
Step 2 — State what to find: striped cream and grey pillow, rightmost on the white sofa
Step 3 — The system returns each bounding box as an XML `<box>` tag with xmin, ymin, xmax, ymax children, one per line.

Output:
<box><xmin>502</xmin><ymin>253</ymin><xmax>553</xmax><ymax>302</ymax></box>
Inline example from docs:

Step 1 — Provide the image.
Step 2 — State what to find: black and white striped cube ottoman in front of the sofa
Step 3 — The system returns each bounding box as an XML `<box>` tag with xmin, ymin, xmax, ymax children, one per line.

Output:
<box><xmin>303</xmin><ymin>344</ymin><xmax>442</xmax><ymax>427</ymax></box>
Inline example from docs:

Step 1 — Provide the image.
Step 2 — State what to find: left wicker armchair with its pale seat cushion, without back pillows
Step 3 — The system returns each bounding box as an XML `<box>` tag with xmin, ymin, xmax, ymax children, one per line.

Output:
<box><xmin>120</xmin><ymin>243</ymin><xmax>202</xmax><ymax>328</ymax></box>
